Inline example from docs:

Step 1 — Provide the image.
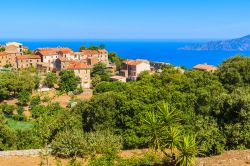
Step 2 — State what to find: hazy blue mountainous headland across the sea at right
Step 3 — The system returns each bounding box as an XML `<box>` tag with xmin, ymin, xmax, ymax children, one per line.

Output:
<box><xmin>179</xmin><ymin>35</ymin><xmax>250</xmax><ymax>51</ymax></box>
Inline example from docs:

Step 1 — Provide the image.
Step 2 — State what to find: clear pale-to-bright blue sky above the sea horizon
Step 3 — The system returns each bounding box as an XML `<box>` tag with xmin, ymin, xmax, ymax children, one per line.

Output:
<box><xmin>0</xmin><ymin>0</ymin><xmax>250</xmax><ymax>39</ymax></box>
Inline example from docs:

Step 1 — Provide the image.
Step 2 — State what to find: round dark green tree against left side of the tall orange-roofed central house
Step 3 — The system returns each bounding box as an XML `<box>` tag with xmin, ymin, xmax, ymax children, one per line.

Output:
<box><xmin>59</xmin><ymin>70</ymin><xmax>80</xmax><ymax>92</ymax></box>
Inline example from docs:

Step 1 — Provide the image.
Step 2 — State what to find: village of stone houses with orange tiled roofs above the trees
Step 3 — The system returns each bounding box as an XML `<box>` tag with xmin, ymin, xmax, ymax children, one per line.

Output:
<box><xmin>0</xmin><ymin>42</ymin><xmax>217</xmax><ymax>89</ymax></box>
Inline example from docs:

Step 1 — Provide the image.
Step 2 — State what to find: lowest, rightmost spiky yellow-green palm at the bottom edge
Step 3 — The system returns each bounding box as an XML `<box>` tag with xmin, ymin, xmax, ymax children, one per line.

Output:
<box><xmin>177</xmin><ymin>135</ymin><xmax>199</xmax><ymax>166</ymax></box>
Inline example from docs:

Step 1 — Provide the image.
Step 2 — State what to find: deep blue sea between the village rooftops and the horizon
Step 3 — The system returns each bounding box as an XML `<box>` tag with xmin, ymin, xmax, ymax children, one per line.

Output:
<box><xmin>0</xmin><ymin>40</ymin><xmax>250</xmax><ymax>68</ymax></box>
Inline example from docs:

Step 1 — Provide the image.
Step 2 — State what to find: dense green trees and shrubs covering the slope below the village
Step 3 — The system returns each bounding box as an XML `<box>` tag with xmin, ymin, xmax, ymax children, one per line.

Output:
<box><xmin>0</xmin><ymin>56</ymin><xmax>250</xmax><ymax>166</ymax></box>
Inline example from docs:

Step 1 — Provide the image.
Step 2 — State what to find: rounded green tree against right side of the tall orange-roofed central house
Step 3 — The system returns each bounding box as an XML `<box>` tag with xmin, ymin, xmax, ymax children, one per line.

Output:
<box><xmin>91</xmin><ymin>63</ymin><xmax>111</xmax><ymax>81</ymax></box>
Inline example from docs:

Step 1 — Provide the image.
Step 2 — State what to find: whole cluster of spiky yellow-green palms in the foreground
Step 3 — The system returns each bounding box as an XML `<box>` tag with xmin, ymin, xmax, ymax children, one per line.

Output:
<box><xmin>143</xmin><ymin>103</ymin><xmax>198</xmax><ymax>166</ymax></box>
